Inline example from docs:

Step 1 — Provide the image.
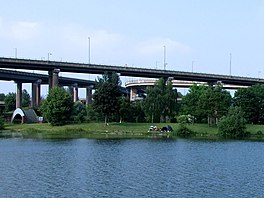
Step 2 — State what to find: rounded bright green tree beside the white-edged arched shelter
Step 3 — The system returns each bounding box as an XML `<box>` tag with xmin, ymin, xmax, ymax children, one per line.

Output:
<box><xmin>41</xmin><ymin>87</ymin><xmax>73</xmax><ymax>126</ymax></box>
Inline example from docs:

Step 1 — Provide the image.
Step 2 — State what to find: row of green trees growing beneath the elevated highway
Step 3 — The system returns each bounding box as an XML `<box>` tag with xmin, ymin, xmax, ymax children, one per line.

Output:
<box><xmin>0</xmin><ymin>73</ymin><xmax>264</xmax><ymax>138</ymax></box>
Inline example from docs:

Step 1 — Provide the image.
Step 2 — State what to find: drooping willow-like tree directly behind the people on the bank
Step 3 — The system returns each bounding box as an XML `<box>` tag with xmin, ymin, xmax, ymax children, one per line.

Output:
<box><xmin>143</xmin><ymin>78</ymin><xmax>177</xmax><ymax>122</ymax></box>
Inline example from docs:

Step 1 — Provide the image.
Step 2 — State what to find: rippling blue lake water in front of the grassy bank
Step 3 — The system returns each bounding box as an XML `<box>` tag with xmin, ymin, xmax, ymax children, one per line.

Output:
<box><xmin>0</xmin><ymin>138</ymin><xmax>264</xmax><ymax>197</ymax></box>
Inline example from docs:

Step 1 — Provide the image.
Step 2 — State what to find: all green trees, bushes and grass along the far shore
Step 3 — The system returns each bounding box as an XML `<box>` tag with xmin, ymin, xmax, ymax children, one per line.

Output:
<box><xmin>0</xmin><ymin>76</ymin><xmax>264</xmax><ymax>139</ymax></box>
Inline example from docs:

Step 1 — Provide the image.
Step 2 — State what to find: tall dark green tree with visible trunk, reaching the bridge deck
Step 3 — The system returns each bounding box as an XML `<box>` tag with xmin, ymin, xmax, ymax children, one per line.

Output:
<box><xmin>93</xmin><ymin>72</ymin><xmax>121</xmax><ymax>124</ymax></box>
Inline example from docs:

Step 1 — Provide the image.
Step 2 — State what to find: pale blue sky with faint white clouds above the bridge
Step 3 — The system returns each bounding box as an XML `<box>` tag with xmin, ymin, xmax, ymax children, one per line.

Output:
<box><xmin>0</xmin><ymin>0</ymin><xmax>264</xmax><ymax>96</ymax></box>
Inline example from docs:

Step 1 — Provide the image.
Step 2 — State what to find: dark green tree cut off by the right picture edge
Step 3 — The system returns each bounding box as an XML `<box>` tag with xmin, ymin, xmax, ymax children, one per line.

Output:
<box><xmin>234</xmin><ymin>85</ymin><xmax>264</xmax><ymax>124</ymax></box>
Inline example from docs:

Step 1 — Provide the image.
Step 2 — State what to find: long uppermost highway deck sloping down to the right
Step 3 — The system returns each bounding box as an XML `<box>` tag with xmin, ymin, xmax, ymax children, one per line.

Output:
<box><xmin>0</xmin><ymin>58</ymin><xmax>264</xmax><ymax>86</ymax></box>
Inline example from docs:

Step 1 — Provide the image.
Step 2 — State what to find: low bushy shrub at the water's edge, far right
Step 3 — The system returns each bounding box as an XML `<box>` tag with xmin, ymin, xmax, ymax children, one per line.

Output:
<box><xmin>218</xmin><ymin>107</ymin><xmax>247</xmax><ymax>137</ymax></box>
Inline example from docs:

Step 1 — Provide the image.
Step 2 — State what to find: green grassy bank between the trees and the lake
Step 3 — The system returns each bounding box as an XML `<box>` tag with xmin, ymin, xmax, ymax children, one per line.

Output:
<box><xmin>3</xmin><ymin>123</ymin><xmax>264</xmax><ymax>140</ymax></box>
